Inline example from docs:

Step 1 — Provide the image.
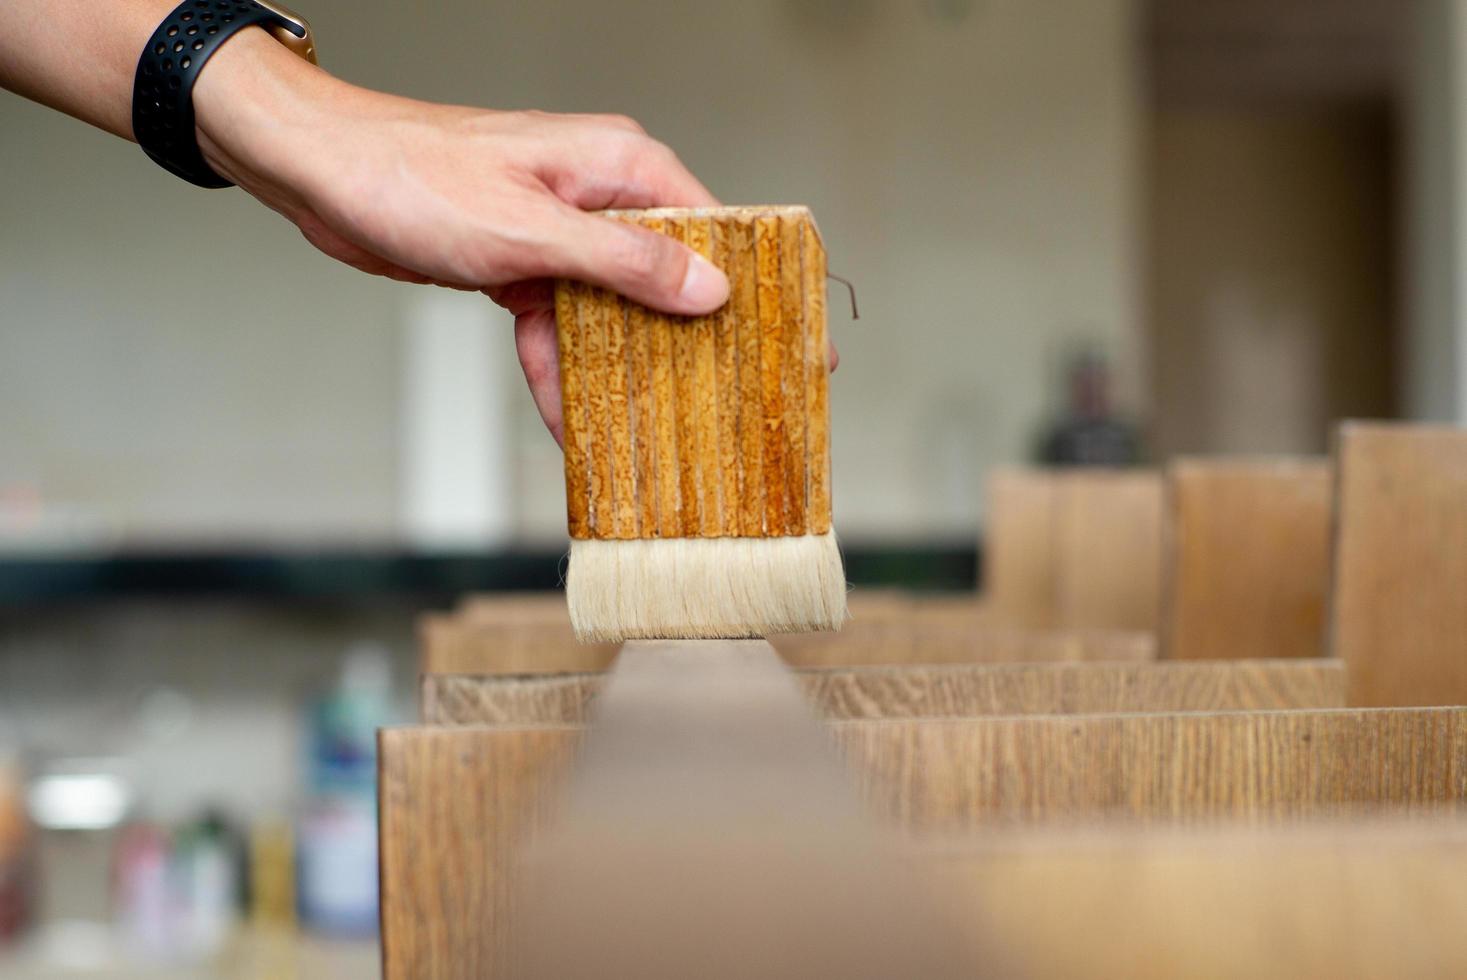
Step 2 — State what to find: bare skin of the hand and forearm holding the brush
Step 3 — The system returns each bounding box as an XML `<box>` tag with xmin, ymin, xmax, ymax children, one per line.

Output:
<box><xmin>0</xmin><ymin>0</ymin><xmax>745</xmax><ymax>442</ymax></box>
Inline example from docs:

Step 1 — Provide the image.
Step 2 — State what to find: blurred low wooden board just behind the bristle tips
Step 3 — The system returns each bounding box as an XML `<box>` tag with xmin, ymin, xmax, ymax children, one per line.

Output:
<box><xmin>418</xmin><ymin>610</ymin><xmax>1156</xmax><ymax>673</ymax></box>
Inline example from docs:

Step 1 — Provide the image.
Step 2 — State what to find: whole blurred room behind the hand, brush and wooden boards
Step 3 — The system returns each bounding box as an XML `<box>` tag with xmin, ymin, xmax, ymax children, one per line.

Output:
<box><xmin>0</xmin><ymin>0</ymin><xmax>1467</xmax><ymax>976</ymax></box>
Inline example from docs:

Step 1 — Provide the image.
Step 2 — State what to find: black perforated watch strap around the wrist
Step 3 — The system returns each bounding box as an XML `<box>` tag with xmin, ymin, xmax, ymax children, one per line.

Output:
<box><xmin>132</xmin><ymin>0</ymin><xmax>298</xmax><ymax>188</ymax></box>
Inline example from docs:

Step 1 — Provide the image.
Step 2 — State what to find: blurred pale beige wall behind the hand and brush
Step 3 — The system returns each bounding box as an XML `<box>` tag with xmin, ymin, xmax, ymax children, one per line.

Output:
<box><xmin>0</xmin><ymin>0</ymin><xmax>1141</xmax><ymax>540</ymax></box>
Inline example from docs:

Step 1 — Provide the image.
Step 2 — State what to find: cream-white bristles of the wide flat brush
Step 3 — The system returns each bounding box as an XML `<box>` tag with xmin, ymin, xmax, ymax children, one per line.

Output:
<box><xmin>565</xmin><ymin>531</ymin><xmax>846</xmax><ymax>643</ymax></box>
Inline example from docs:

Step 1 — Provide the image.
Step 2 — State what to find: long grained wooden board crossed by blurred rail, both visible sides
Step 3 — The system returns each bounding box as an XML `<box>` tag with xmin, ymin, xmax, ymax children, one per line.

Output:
<box><xmin>378</xmin><ymin>709</ymin><xmax>1467</xmax><ymax>980</ymax></box>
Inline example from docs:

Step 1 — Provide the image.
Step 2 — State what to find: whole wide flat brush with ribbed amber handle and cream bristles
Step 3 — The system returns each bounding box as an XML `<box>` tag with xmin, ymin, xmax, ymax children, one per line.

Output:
<box><xmin>556</xmin><ymin>207</ymin><xmax>846</xmax><ymax>641</ymax></box>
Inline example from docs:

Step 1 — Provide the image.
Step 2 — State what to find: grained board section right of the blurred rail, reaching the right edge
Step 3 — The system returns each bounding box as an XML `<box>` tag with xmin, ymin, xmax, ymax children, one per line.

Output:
<box><xmin>850</xmin><ymin>707</ymin><xmax>1467</xmax><ymax>832</ymax></box>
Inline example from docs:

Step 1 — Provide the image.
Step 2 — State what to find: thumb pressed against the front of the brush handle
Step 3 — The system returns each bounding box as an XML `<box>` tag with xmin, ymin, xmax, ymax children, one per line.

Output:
<box><xmin>547</xmin><ymin>208</ymin><xmax>729</xmax><ymax>315</ymax></box>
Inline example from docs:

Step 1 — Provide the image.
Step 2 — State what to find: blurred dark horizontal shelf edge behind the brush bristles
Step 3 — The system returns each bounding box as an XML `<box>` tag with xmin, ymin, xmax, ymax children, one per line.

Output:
<box><xmin>0</xmin><ymin>544</ymin><xmax>978</xmax><ymax>606</ymax></box>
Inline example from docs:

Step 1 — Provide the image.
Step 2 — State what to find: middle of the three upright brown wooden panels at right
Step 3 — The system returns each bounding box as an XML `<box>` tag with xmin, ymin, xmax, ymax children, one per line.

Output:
<box><xmin>1162</xmin><ymin>459</ymin><xmax>1334</xmax><ymax>660</ymax></box>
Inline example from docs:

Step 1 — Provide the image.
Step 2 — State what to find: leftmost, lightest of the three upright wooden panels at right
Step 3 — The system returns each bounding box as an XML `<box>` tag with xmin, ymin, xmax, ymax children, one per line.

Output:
<box><xmin>984</xmin><ymin>468</ymin><xmax>1162</xmax><ymax>631</ymax></box>
